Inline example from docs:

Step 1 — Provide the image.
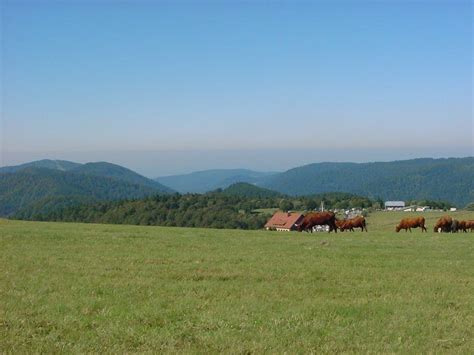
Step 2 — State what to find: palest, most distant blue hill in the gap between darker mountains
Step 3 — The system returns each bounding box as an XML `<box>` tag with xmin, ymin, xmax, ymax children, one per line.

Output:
<box><xmin>155</xmin><ymin>169</ymin><xmax>275</xmax><ymax>193</ymax></box>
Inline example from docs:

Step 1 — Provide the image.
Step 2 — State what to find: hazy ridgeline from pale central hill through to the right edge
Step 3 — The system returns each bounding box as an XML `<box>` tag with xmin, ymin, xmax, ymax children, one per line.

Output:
<box><xmin>156</xmin><ymin>157</ymin><xmax>474</xmax><ymax>207</ymax></box>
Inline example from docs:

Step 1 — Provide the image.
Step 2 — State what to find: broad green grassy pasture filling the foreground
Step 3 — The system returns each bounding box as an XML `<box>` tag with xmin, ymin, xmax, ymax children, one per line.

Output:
<box><xmin>0</xmin><ymin>212</ymin><xmax>474</xmax><ymax>353</ymax></box>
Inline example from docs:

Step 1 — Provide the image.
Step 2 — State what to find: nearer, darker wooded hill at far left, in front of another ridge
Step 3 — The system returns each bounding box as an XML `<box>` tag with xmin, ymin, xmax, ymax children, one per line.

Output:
<box><xmin>0</xmin><ymin>167</ymin><xmax>171</xmax><ymax>216</ymax></box>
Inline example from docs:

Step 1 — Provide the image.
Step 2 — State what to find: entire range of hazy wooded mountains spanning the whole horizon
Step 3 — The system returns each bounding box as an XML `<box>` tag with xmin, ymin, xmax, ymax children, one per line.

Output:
<box><xmin>0</xmin><ymin>157</ymin><xmax>474</xmax><ymax>216</ymax></box>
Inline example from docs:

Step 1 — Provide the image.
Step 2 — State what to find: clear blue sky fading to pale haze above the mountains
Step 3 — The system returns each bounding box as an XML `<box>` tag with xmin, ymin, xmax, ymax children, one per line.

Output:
<box><xmin>0</xmin><ymin>0</ymin><xmax>474</xmax><ymax>177</ymax></box>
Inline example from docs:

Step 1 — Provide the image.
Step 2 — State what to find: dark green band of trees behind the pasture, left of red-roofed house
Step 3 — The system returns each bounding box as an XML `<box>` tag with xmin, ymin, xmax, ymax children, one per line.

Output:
<box><xmin>13</xmin><ymin>191</ymin><xmax>377</xmax><ymax>229</ymax></box>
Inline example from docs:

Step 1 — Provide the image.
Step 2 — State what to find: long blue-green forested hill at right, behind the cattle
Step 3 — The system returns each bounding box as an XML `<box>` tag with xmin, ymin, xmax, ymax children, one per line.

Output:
<box><xmin>259</xmin><ymin>157</ymin><xmax>474</xmax><ymax>207</ymax></box>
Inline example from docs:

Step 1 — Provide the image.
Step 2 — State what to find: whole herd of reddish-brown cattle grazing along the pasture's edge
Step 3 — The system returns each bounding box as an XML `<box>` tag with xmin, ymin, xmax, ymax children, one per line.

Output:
<box><xmin>296</xmin><ymin>211</ymin><xmax>474</xmax><ymax>233</ymax></box>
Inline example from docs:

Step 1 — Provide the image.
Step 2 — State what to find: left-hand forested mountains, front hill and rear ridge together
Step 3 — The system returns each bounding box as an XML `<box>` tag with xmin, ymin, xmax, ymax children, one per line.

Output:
<box><xmin>0</xmin><ymin>161</ymin><xmax>173</xmax><ymax>216</ymax></box>
